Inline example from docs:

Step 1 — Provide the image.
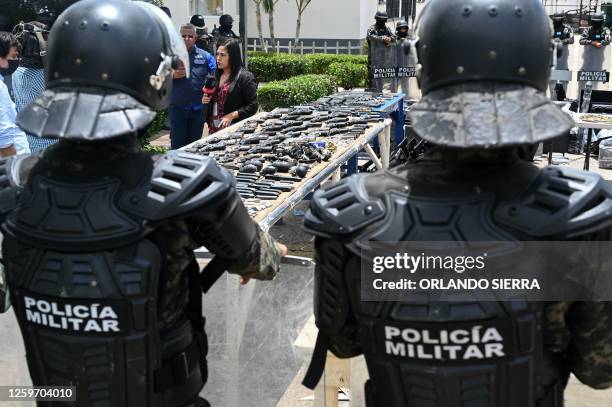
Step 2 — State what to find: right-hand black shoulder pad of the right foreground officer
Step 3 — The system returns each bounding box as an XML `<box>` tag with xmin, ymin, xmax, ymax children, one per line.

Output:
<box><xmin>495</xmin><ymin>167</ymin><xmax>612</xmax><ymax>239</ymax></box>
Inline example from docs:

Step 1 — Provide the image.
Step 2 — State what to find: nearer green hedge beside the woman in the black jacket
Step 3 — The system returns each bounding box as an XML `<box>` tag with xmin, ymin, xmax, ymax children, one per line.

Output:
<box><xmin>258</xmin><ymin>75</ymin><xmax>337</xmax><ymax>112</ymax></box>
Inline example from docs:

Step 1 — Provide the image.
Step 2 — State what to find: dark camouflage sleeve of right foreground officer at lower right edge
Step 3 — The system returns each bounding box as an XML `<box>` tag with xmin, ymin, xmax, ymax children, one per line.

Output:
<box><xmin>546</xmin><ymin>302</ymin><xmax>612</xmax><ymax>389</ymax></box>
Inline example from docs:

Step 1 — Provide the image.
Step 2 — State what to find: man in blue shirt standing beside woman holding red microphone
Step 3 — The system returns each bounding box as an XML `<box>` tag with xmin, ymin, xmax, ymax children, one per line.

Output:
<box><xmin>168</xmin><ymin>24</ymin><xmax>217</xmax><ymax>149</ymax></box>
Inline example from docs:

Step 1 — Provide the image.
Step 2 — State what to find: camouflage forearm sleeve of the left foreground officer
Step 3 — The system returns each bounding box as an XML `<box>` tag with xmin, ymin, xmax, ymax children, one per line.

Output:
<box><xmin>227</xmin><ymin>227</ymin><xmax>281</xmax><ymax>280</ymax></box>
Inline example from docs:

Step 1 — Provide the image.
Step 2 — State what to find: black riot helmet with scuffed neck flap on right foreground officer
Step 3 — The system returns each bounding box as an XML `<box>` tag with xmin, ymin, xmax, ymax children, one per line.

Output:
<box><xmin>410</xmin><ymin>0</ymin><xmax>572</xmax><ymax>148</ymax></box>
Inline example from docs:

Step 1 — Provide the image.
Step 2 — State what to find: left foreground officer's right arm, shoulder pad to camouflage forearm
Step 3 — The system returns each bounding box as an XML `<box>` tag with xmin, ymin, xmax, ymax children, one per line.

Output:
<box><xmin>146</xmin><ymin>151</ymin><xmax>280</xmax><ymax>279</ymax></box>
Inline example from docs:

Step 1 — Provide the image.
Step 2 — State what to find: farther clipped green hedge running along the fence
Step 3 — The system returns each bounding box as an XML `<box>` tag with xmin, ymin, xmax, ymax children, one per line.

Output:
<box><xmin>249</xmin><ymin>52</ymin><xmax>368</xmax><ymax>82</ymax></box>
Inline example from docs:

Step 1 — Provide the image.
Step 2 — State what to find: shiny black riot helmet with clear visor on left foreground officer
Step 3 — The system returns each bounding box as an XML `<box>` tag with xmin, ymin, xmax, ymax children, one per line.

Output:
<box><xmin>17</xmin><ymin>0</ymin><xmax>189</xmax><ymax>140</ymax></box>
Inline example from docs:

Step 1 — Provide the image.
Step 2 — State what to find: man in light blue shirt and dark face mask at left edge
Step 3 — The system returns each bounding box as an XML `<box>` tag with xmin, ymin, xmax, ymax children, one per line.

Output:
<box><xmin>0</xmin><ymin>32</ymin><xmax>30</xmax><ymax>157</ymax></box>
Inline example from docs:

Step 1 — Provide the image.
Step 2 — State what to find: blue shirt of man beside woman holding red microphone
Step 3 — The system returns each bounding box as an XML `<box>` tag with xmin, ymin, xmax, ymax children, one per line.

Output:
<box><xmin>170</xmin><ymin>45</ymin><xmax>217</xmax><ymax>110</ymax></box>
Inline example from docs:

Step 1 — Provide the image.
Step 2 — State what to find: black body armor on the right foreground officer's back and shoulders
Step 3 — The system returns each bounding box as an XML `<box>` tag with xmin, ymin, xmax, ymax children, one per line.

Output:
<box><xmin>304</xmin><ymin>155</ymin><xmax>612</xmax><ymax>407</ymax></box>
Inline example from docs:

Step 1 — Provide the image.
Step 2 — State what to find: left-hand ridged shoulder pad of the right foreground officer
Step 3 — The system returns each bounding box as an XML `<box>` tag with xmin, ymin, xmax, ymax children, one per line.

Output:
<box><xmin>304</xmin><ymin>174</ymin><xmax>385</xmax><ymax>237</ymax></box>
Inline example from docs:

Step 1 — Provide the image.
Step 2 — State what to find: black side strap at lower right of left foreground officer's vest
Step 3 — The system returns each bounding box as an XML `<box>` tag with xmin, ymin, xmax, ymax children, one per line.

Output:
<box><xmin>154</xmin><ymin>335</ymin><xmax>204</xmax><ymax>393</ymax></box>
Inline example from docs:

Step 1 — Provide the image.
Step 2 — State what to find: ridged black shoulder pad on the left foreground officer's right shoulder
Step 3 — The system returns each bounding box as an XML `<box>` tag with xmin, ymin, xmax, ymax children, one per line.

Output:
<box><xmin>144</xmin><ymin>151</ymin><xmax>232</xmax><ymax>220</ymax></box>
